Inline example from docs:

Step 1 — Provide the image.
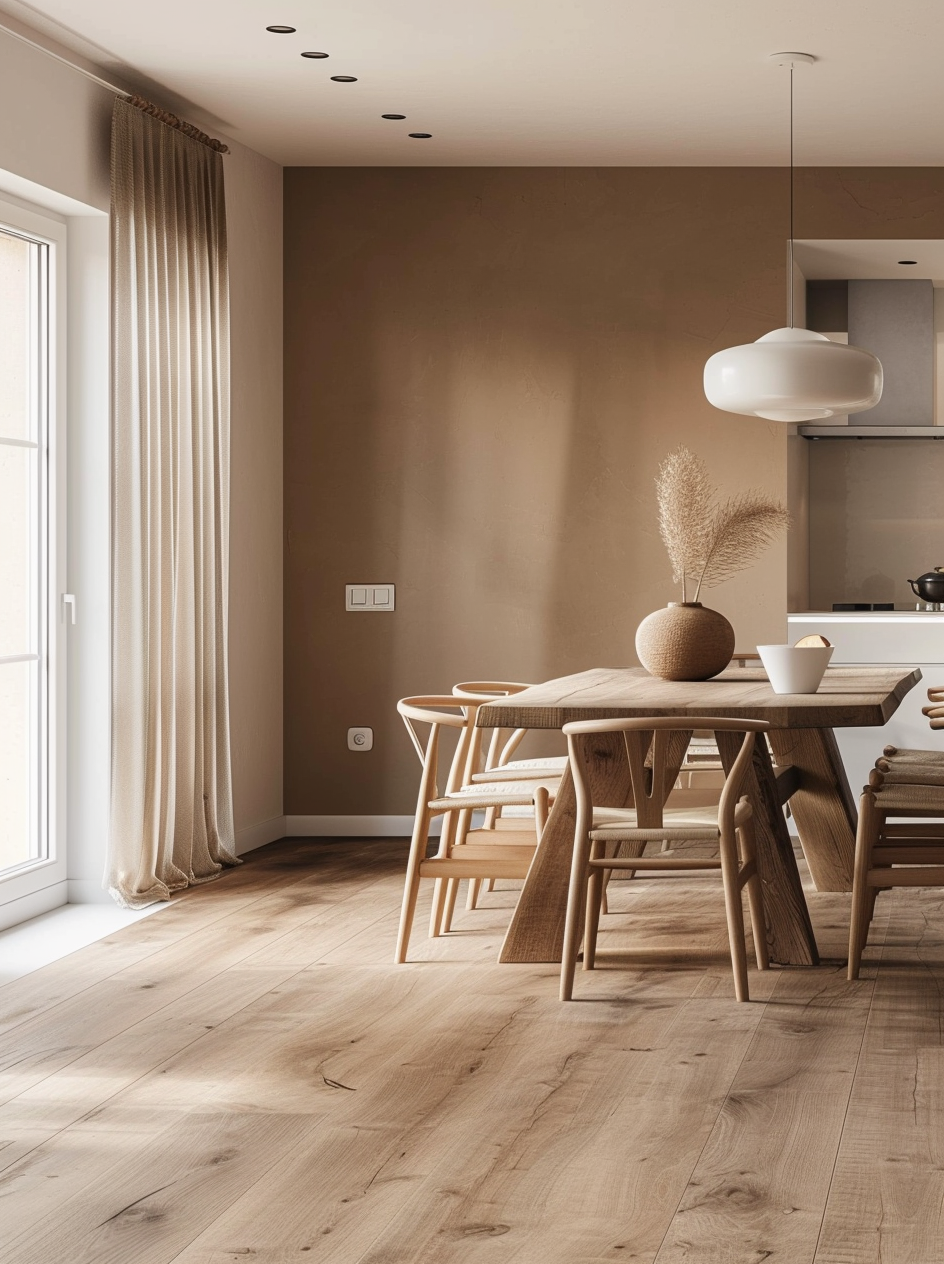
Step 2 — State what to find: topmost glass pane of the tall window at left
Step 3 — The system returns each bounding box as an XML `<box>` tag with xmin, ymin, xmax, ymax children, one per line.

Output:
<box><xmin>0</xmin><ymin>230</ymin><xmax>35</xmax><ymax>439</ymax></box>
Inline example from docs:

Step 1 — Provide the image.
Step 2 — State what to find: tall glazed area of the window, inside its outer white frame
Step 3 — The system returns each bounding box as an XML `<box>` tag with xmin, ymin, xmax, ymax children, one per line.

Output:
<box><xmin>0</xmin><ymin>206</ymin><xmax>62</xmax><ymax>899</ymax></box>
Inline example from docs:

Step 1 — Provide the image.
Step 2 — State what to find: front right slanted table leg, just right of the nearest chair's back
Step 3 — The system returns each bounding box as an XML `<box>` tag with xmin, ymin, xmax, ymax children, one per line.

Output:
<box><xmin>717</xmin><ymin>729</ymin><xmax>819</xmax><ymax>966</ymax></box>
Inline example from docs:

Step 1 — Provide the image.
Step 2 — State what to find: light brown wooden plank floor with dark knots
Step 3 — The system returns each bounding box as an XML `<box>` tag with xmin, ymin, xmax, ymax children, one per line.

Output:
<box><xmin>0</xmin><ymin>839</ymin><xmax>944</xmax><ymax>1264</ymax></box>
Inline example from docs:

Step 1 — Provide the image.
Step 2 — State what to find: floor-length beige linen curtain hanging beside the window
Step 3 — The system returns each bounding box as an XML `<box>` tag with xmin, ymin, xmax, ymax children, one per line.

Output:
<box><xmin>105</xmin><ymin>99</ymin><xmax>236</xmax><ymax>908</ymax></box>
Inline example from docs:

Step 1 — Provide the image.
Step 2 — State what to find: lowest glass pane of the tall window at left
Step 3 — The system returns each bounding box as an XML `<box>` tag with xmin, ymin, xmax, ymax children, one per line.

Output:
<box><xmin>0</xmin><ymin>662</ymin><xmax>39</xmax><ymax>871</ymax></box>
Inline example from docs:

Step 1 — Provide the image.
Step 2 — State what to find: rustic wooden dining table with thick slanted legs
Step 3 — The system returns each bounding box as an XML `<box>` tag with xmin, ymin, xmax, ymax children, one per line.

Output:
<box><xmin>478</xmin><ymin>666</ymin><xmax>921</xmax><ymax>966</ymax></box>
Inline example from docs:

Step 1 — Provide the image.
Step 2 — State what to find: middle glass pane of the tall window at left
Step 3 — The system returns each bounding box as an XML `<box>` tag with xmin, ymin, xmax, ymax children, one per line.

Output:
<box><xmin>0</xmin><ymin>442</ymin><xmax>38</xmax><ymax>657</ymax></box>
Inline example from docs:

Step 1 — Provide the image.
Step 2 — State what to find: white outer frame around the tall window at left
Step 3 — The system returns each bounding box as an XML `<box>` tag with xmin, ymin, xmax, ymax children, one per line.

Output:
<box><xmin>0</xmin><ymin>196</ymin><xmax>68</xmax><ymax>923</ymax></box>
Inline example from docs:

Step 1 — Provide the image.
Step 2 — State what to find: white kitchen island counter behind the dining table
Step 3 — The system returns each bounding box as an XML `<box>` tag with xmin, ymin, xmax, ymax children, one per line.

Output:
<box><xmin>787</xmin><ymin>611</ymin><xmax>944</xmax><ymax>798</ymax></box>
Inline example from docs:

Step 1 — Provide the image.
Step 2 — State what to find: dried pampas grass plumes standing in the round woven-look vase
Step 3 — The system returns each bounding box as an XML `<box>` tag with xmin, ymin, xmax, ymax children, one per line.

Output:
<box><xmin>656</xmin><ymin>447</ymin><xmax>790</xmax><ymax>602</ymax></box>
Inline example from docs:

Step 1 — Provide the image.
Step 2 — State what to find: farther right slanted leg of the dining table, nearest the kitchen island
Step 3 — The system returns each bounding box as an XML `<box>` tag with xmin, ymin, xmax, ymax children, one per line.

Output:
<box><xmin>770</xmin><ymin>728</ymin><xmax>858</xmax><ymax>891</ymax></box>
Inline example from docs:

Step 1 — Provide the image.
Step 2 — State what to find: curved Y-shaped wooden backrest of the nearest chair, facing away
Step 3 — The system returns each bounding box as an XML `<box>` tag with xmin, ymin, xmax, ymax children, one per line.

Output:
<box><xmin>564</xmin><ymin>715</ymin><xmax>770</xmax><ymax>829</ymax></box>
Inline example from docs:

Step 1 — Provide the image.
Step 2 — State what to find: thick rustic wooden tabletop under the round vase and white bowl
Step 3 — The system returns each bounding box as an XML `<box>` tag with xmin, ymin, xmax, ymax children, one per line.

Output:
<box><xmin>478</xmin><ymin>667</ymin><xmax>921</xmax><ymax>728</ymax></box>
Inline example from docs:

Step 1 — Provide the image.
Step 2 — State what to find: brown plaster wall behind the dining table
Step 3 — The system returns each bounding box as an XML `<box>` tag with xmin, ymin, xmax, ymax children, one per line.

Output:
<box><xmin>284</xmin><ymin>168</ymin><xmax>944</xmax><ymax>814</ymax></box>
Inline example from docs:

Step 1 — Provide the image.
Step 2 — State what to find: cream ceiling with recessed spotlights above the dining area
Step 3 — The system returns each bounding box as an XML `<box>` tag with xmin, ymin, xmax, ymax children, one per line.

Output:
<box><xmin>0</xmin><ymin>0</ymin><xmax>944</xmax><ymax>167</ymax></box>
